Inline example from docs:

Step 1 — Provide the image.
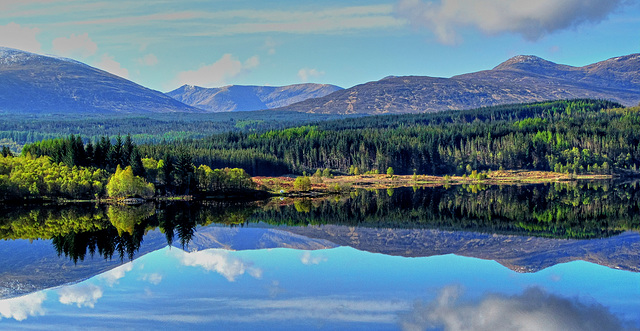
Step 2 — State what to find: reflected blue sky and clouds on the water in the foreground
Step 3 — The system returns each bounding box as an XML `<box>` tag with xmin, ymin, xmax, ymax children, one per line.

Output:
<box><xmin>0</xmin><ymin>247</ymin><xmax>640</xmax><ymax>330</ymax></box>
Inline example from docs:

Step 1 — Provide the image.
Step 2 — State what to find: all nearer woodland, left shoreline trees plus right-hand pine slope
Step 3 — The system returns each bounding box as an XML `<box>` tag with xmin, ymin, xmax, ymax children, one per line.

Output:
<box><xmin>0</xmin><ymin>100</ymin><xmax>640</xmax><ymax>200</ymax></box>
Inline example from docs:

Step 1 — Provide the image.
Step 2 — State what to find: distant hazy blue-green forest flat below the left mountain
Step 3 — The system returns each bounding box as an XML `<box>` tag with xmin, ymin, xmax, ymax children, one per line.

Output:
<box><xmin>0</xmin><ymin>111</ymin><xmax>340</xmax><ymax>153</ymax></box>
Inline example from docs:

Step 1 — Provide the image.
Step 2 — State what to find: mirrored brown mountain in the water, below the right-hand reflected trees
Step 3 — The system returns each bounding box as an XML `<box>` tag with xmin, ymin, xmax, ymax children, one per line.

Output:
<box><xmin>285</xmin><ymin>225</ymin><xmax>640</xmax><ymax>272</ymax></box>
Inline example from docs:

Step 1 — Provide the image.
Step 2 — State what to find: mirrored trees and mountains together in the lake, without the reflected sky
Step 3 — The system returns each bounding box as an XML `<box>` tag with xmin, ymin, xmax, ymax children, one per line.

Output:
<box><xmin>0</xmin><ymin>183</ymin><xmax>640</xmax><ymax>296</ymax></box>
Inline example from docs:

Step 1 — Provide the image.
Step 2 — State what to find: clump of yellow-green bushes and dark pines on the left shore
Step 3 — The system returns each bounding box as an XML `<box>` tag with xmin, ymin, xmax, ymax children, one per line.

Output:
<box><xmin>0</xmin><ymin>135</ymin><xmax>255</xmax><ymax>200</ymax></box>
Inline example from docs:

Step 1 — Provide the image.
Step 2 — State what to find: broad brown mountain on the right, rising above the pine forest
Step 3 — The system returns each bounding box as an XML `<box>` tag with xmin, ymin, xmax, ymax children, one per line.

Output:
<box><xmin>281</xmin><ymin>54</ymin><xmax>640</xmax><ymax>114</ymax></box>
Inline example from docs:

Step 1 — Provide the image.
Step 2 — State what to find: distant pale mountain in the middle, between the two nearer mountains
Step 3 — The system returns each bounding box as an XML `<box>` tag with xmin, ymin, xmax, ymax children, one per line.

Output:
<box><xmin>167</xmin><ymin>84</ymin><xmax>342</xmax><ymax>112</ymax></box>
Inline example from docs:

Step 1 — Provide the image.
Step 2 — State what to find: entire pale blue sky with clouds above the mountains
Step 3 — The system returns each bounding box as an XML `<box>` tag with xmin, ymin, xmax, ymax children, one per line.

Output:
<box><xmin>0</xmin><ymin>0</ymin><xmax>640</xmax><ymax>92</ymax></box>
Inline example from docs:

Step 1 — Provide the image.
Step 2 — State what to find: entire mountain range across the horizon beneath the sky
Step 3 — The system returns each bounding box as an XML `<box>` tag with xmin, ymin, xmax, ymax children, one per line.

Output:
<box><xmin>0</xmin><ymin>47</ymin><xmax>640</xmax><ymax>115</ymax></box>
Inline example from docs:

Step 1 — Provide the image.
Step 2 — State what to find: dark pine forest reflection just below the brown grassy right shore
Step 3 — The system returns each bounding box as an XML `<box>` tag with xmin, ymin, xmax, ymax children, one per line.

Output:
<box><xmin>251</xmin><ymin>183</ymin><xmax>640</xmax><ymax>239</ymax></box>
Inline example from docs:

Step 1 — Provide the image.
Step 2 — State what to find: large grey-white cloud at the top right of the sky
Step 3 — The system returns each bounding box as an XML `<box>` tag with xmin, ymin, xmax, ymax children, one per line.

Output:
<box><xmin>396</xmin><ymin>0</ymin><xmax>624</xmax><ymax>44</ymax></box>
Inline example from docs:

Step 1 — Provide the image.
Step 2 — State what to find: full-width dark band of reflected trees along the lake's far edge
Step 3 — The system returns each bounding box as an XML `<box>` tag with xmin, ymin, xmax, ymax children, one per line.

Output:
<box><xmin>0</xmin><ymin>183</ymin><xmax>640</xmax><ymax>262</ymax></box>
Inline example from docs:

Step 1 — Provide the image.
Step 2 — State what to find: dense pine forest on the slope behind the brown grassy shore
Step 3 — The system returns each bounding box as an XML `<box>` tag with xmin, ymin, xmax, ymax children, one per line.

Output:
<box><xmin>140</xmin><ymin>100</ymin><xmax>640</xmax><ymax>175</ymax></box>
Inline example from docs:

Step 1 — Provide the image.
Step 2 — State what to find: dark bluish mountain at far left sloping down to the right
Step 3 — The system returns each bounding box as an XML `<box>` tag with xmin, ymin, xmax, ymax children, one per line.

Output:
<box><xmin>0</xmin><ymin>47</ymin><xmax>200</xmax><ymax>114</ymax></box>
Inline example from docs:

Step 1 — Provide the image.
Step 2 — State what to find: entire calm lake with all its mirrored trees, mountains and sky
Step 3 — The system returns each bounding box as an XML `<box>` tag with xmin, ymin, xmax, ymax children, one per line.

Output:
<box><xmin>0</xmin><ymin>182</ymin><xmax>640</xmax><ymax>330</ymax></box>
